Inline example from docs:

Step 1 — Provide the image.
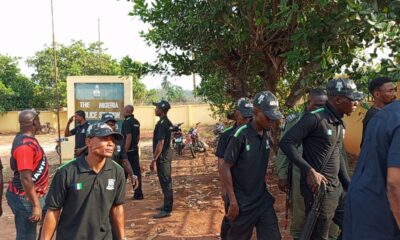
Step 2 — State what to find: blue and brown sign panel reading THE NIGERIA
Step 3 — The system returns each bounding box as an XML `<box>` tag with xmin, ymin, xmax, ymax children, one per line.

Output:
<box><xmin>75</xmin><ymin>83</ymin><xmax>124</xmax><ymax>121</ymax></box>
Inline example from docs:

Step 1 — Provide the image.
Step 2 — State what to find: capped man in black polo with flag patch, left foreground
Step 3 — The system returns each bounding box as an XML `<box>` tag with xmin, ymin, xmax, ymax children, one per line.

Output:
<box><xmin>41</xmin><ymin>122</ymin><xmax>125</xmax><ymax>240</ymax></box>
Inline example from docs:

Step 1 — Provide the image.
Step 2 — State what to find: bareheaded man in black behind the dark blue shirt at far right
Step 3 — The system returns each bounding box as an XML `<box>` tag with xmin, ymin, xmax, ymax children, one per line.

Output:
<box><xmin>361</xmin><ymin>77</ymin><xmax>396</xmax><ymax>146</ymax></box>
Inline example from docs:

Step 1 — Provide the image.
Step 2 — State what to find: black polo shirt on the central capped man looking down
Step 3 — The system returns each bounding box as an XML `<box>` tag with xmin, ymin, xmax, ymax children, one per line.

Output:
<box><xmin>224</xmin><ymin>122</ymin><xmax>274</xmax><ymax>212</ymax></box>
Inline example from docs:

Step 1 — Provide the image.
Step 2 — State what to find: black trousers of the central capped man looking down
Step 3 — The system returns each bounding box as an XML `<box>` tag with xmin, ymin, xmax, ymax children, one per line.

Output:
<box><xmin>227</xmin><ymin>206</ymin><xmax>281</xmax><ymax>240</ymax></box>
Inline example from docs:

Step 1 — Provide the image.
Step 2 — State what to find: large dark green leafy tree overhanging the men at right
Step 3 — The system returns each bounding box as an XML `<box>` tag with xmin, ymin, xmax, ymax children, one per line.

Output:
<box><xmin>131</xmin><ymin>0</ymin><xmax>400</xmax><ymax>113</ymax></box>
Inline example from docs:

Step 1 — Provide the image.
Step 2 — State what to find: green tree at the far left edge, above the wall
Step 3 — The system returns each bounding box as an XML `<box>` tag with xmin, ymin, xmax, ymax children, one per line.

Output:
<box><xmin>0</xmin><ymin>55</ymin><xmax>36</xmax><ymax>112</ymax></box>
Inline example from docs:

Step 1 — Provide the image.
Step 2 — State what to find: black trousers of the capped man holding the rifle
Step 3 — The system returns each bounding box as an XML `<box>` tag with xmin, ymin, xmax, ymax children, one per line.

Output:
<box><xmin>304</xmin><ymin>190</ymin><xmax>345</xmax><ymax>240</ymax></box>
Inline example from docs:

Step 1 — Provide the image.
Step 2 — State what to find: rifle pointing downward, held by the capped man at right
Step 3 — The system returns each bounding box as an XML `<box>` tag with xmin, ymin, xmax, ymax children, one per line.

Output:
<box><xmin>300</xmin><ymin>182</ymin><xmax>326</xmax><ymax>240</ymax></box>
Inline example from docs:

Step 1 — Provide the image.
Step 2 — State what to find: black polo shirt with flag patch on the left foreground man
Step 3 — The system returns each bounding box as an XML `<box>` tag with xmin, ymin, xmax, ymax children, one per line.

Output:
<box><xmin>46</xmin><ymin>156</ymin><xmax>125</xmax><ymax>240</ymax></box>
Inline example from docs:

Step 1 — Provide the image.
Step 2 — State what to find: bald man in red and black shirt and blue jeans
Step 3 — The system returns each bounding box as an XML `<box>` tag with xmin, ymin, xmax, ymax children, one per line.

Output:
<box><xmin>6</xmin><ymin>110</ymin><xmax>49</xmax><ymax>240</ymax></box>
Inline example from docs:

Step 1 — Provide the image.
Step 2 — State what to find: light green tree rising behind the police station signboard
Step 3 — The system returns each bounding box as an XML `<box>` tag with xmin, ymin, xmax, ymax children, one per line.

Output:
<box><xmin>27</xmin><ymin>41</ymin><xmax>121</xmax><ymax>108</ymax></box>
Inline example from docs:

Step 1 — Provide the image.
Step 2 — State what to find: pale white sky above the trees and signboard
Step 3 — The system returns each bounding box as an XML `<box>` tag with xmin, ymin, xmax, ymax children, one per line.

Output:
<box><xmin>0</xmin><ymin>0</ymin><xmax>193</xmax><ymax>90</ymax></box>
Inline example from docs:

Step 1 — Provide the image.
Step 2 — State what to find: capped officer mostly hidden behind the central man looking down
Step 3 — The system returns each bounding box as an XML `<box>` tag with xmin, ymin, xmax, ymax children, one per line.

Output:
<box><xmin>215</xmin><ymin>98</ymin><xmax>253</xmax><ymax>239</ymax></box>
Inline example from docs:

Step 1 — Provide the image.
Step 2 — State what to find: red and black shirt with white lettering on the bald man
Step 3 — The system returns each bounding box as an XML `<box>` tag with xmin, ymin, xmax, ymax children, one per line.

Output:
<box><xmin>8</xmin><ymin>134</ymin><xmax>49</xmax><ymax>196</ymax></box>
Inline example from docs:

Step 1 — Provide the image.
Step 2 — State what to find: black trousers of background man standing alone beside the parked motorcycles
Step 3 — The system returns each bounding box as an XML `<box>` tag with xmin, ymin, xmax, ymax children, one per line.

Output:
<box><xmin>157</xmin><ymin>149</ymin><xmax>174</xmax><ymax>212</ymax></box>
